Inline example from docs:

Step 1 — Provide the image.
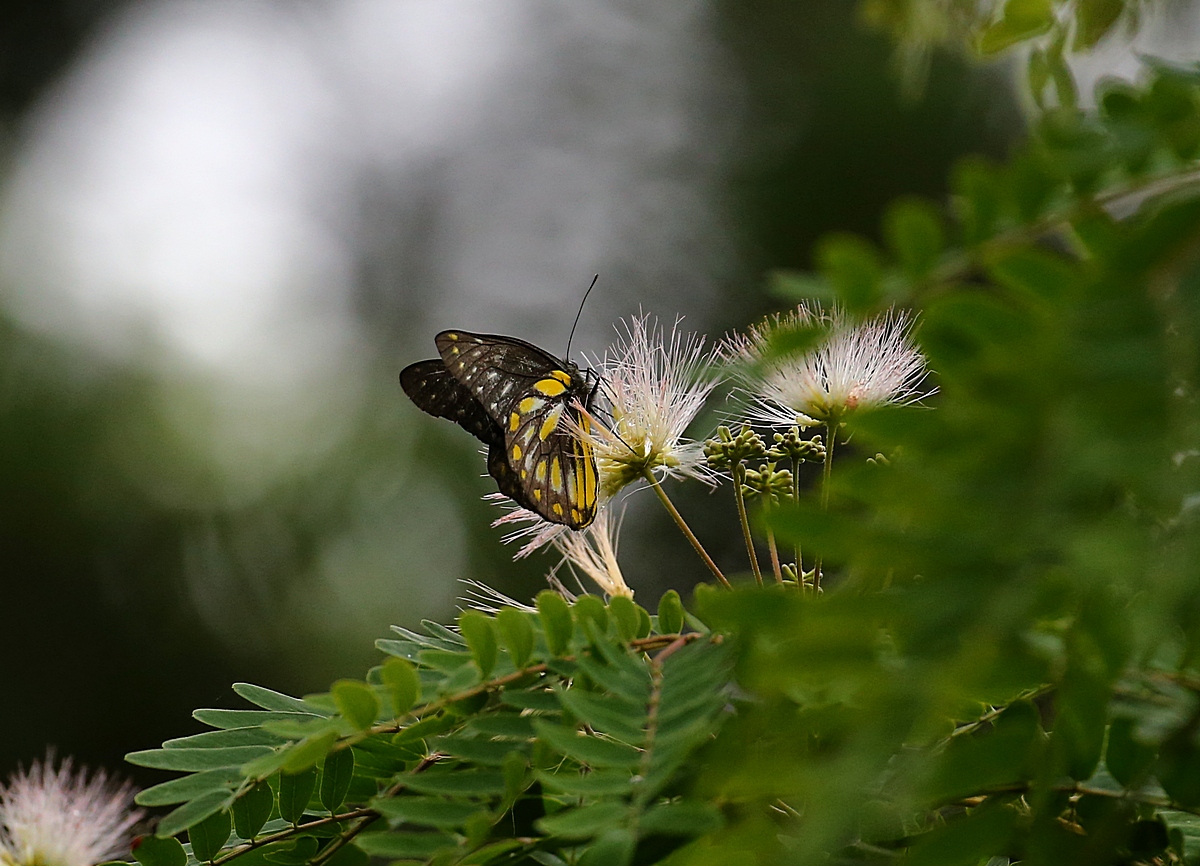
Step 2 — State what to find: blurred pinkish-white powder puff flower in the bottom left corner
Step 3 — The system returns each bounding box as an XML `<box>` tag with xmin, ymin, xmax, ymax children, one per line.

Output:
<box><xmin>0</xmin><ymin>756</ymin><xmax>142</xmax><ymax>866</ymax></box>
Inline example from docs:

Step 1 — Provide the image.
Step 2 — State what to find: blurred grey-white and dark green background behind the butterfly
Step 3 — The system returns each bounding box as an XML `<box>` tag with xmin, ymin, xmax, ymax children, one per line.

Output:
<box><xmin>0</xmin><ymin>0</ymin><xmax>1176</xmax><ymax>783</ymax></box>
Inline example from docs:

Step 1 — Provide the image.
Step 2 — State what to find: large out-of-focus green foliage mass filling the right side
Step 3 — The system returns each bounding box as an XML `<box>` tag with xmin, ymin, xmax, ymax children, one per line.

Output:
<box><xmin>686</xmin><ymin>62</ymin><xmax>1200</xmax><ymax>864</ymax></box>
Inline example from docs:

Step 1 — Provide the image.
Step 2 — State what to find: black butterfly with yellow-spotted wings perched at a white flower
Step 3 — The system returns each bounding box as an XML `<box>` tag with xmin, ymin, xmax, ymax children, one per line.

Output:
<box><xmin>400</xmin><ymin>331</ymin><xmax>598</xmax><ymax>529</ymax></box>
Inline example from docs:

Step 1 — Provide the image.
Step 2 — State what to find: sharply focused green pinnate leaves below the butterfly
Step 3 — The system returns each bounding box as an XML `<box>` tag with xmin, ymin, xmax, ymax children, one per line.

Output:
<box><xmin>127</xmin><ymin>591</ymin><xmax>732</xmax><ymax>866</ymax></box>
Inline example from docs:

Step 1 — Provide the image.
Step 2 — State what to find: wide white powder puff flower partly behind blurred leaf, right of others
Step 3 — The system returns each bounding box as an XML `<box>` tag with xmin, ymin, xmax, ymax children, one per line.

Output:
<box><xmin>724</xmin><ymin>305</ymin><xmax>935</xmax><ymax>427</ymax></box>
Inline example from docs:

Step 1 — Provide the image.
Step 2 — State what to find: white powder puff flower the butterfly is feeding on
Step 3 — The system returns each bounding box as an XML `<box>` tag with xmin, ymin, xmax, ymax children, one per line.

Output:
<box><xmin>571</xmin><ymin>313</ymin><xmax>718</xmax><ymax>497</ymax></box>
